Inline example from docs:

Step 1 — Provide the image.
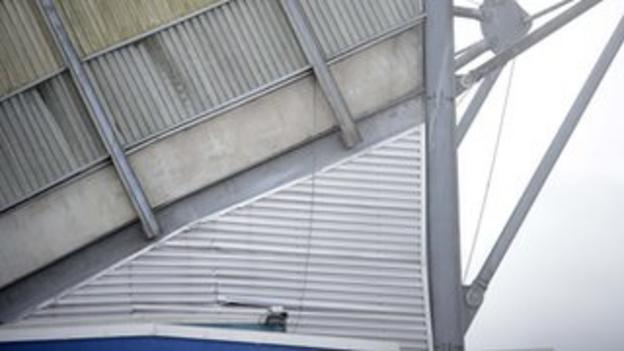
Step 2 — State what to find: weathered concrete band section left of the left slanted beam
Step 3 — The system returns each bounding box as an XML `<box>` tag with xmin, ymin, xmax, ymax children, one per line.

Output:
<box><xmin>0</xmin><ymin>167</ymin><xmax>135</xmax><ymax>286</ymax></box>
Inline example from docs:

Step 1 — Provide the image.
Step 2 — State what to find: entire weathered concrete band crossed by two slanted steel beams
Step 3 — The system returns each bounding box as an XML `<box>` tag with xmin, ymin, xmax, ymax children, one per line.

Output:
<box><xmin>0</xmin><ymin>30</ymin><xmax>422</xmax><ymax>286</ymax></box>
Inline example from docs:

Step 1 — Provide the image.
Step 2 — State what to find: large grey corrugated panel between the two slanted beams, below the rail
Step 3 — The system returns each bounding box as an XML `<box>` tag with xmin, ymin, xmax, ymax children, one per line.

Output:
<box><xmin>83</xmin><ymin>0</ymin><xmax>306</xmax><ymax>144</ymax></box>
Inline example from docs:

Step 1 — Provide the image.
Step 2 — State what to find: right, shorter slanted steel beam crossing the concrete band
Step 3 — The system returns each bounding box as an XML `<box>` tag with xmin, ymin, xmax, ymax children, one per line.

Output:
<box><xmin>282</xmin><ymin>0</ymin><xmax>362</xmax><ymax>148</ymax></box>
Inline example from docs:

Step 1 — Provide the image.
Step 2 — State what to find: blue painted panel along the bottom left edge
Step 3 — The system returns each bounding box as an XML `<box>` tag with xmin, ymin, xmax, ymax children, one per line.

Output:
<box><xmin>0</xmin><ymin>337</ymin><xmax>329</xmax><ymax>351</ymax></box>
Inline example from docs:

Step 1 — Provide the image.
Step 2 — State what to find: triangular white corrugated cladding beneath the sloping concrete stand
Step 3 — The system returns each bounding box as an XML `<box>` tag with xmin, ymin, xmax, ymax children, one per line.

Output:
<box><xmin>22</xmin><ymin>125</ymin><xmax>430</xmax><ymax>350</ymax></box>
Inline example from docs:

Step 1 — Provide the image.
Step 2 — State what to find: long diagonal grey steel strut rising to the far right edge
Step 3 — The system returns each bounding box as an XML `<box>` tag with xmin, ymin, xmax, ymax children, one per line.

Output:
<box><xmin>465</xmin><ymin>17</ymin><xmax>624</xmax><ymax>329</ymax></box>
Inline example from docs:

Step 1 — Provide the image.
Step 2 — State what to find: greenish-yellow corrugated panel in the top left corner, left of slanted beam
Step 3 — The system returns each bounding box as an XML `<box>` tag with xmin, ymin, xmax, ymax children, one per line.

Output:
<box><xmin>0</xmin><ymin>0</ymin><xmax>62</xmax><ymax>97</ymax></box>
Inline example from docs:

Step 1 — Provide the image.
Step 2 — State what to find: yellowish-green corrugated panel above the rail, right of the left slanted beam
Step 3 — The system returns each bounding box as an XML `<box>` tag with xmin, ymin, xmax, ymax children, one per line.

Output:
<box><xmin>56</xmin><ymin>0</ymin><xmax>219</xmax><ymax>55</ymax></box>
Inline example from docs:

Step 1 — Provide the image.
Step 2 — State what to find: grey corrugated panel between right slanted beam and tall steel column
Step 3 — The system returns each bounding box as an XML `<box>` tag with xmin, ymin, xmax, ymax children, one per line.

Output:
<box><xmin>302</xmin><ymin>0</ymin><xmax>422</xmax><ymax>57</ymax></box>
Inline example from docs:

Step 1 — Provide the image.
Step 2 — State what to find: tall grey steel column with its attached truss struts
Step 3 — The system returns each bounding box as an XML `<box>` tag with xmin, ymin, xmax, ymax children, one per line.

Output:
<box><xmin>425</xmin><ymin>0</ymin><xmax>624</xmax><ymax>350</ymax></box>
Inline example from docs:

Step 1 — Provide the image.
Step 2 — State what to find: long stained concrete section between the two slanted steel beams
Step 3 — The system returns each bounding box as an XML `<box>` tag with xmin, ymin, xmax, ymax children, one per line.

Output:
<box><xmin>130</xmin><ymin>77</ymin><xmax>334</xmax><ymax>205</ymax></box>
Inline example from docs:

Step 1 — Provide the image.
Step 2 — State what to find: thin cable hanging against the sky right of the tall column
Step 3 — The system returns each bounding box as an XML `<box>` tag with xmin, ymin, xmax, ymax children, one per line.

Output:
<box><xmin>463</xmin><ymin>60</ymin><xmax>516</xmax><ymax>281</ymax></box>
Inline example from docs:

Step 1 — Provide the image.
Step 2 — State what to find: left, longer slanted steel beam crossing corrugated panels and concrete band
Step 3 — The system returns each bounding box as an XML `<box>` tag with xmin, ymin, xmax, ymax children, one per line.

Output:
<box><xmin>40</xmin><ymin>0</ymin><xmax>160</xmax><ymax>238</ymax></box>
